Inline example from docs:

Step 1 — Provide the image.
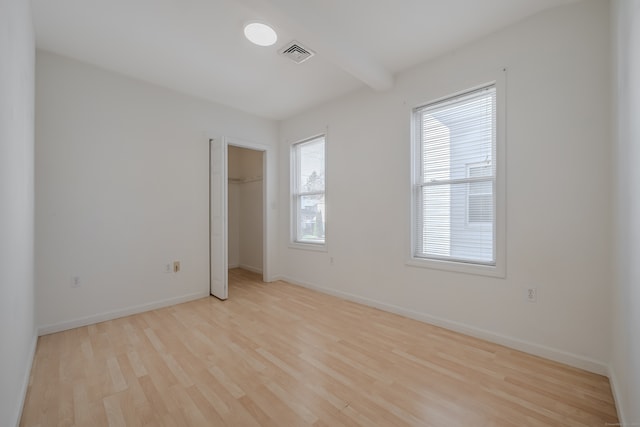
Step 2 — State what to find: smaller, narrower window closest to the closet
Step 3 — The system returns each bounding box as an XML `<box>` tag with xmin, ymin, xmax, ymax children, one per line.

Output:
<box><xmin>291</xmin><ymin>135</ymin><xmax>326</xmax><ymax>246</ymax></box>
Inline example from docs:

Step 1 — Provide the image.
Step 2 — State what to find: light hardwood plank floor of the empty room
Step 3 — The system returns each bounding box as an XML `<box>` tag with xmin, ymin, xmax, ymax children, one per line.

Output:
<box><xmin>20</xmin><ymin>270</ymin><xmax>617</xmax><ymax>427</ymax></box>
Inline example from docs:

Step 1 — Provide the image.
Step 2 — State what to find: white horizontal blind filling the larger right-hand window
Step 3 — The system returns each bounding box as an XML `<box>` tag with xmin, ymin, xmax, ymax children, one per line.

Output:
<box><xmin>413</xmin><ymin>85</ymin><xmax>496</xmax><ymax>265</ymax></box>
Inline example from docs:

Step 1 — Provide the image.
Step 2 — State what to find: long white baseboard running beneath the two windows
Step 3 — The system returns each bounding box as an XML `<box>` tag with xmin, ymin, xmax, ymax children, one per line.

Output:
<box><xmin>278</xmin><ymin>276</ymin><xmax>609</xmax><ymax>376</ymax></box>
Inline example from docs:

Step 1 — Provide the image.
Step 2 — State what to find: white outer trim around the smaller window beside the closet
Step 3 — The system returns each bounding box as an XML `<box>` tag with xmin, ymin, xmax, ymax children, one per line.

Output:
<box><xmin>288</xmin><ymin>132</ymin><xmax>329</xmax><ymax>252</ymax></box>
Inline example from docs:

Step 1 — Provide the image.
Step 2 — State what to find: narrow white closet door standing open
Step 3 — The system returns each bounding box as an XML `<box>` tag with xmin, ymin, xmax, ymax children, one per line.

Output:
<box><xmin>209</xmin><ymin>138</ymin><xmax>228</xmax><ymax>300</ymax></box>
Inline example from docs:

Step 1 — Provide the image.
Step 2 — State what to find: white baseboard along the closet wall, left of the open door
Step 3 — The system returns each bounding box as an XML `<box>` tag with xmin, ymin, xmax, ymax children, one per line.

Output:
<box><xmin>38</xmin><ymin>289</ymin><xmax>209</xmax><ymax>336</ymax></box>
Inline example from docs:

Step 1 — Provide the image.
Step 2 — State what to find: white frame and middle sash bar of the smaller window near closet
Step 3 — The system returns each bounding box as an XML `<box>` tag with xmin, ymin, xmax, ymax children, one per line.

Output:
<box><xmin>289</xmin><ymin>133</ymin><xmax>328</xmax><ymax>252</ymax></box>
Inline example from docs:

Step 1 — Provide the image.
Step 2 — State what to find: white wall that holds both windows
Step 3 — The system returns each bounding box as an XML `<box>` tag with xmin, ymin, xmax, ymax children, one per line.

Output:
<box><xmin>280</xmin><ymin>0</ymin><xmax>612</xmax><ymax>373</ymax></box>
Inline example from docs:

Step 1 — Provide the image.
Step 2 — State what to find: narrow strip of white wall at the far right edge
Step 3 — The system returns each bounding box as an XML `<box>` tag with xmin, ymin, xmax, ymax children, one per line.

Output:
<box><xmin>611</xmin><ymin>0</ymin><xmax>640</xmax><ymax>425</ymax></box>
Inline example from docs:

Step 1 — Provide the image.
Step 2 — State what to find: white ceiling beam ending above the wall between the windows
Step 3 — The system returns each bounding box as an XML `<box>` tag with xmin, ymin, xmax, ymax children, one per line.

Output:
<box><xmin>238</xmin><ymin>0</ymin><xmax>394</xmax><ymax>91</ymax></box>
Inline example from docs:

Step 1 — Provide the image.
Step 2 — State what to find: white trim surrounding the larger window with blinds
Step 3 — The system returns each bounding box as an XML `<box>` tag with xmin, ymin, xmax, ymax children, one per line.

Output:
<box><xmin>405</xmin><ymin>69</ymin><xmax>507</xmax><ymax>278</ymax></box>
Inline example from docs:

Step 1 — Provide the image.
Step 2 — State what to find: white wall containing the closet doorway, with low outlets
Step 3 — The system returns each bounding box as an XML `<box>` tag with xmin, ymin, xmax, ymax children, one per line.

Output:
<box><xmin>35</xmin><ymin>52</ymin><xmax>277</xmax><ymax>332</ymax></box>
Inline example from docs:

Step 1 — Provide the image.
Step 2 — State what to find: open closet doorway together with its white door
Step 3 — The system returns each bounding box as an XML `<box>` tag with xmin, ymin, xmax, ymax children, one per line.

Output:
<box><xmin>209</xmin><ymin>137</ymin><xmax>268</xmax><ymax>300</ymax></box>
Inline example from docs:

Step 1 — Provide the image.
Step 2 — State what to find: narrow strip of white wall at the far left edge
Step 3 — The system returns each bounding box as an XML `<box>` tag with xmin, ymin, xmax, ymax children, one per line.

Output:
<box><xmin>0</xmin><ymin>0</ymin><xmax>36</xmax><ymax>426</ymax></box>
